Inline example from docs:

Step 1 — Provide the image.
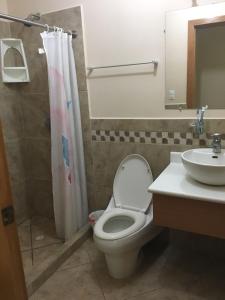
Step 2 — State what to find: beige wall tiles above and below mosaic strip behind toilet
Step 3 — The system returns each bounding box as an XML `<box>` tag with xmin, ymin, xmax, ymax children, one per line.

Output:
<box><xmin>91</xmin><ymin>119</ymin><xmax>225</xmax><ymax>213</ymax></box>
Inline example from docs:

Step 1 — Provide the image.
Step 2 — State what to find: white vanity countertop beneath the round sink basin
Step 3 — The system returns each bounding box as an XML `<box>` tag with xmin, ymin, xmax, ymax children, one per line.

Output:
<box><xmin>149</xmin><ymin>152</ymin><xmax>225</xmax><ymax>204</ymax></box>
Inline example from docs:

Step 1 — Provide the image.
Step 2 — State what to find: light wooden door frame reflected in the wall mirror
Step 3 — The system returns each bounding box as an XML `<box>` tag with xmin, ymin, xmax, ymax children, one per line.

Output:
<box><xmin>187</xmin><ymin>16</ymin><xmax>225</xmax><ymax>109</ymax></box>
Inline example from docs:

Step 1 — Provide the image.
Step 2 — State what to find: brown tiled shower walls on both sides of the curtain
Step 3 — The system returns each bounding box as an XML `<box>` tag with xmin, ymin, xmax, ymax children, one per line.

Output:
<box><xmin>0</xmin><ymin>7</ymin><xmax>91</xmax><ymax>221</ymax></box>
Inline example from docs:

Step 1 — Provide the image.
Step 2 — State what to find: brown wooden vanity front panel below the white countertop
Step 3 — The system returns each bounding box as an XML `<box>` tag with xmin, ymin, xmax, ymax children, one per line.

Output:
<box><xmin>153</xmin><ymin>194</ymin><xmax>225</xmax><ymax>239</ymax></box>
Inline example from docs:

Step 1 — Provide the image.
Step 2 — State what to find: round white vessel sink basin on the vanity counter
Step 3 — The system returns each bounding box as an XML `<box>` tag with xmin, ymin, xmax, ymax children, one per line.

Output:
<box><xmin>181</xmin><ymin>148</ymin><xmax>225</xmax><ymax>185</ymax></box>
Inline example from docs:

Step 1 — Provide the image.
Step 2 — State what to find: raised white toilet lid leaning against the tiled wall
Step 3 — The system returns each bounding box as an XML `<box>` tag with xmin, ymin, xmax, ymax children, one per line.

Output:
<box><xmin>113</xmin><ymin>154</ymin><xmax>153</xmax><ymax>212</ymax></box>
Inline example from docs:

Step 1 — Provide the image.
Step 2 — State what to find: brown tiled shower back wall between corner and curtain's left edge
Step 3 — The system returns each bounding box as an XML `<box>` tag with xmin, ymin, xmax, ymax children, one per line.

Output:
<box><xmin>10</xmin><ymin>17</ymin><xmax>53</xmax><ymax>223</ymax></box>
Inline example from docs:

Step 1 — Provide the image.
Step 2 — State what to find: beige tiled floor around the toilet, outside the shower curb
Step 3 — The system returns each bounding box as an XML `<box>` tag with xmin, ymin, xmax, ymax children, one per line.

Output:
<box><xmin>27</xmin><ymin>239</ymin><xmax>225</xmax><ymax>300</ymax></box>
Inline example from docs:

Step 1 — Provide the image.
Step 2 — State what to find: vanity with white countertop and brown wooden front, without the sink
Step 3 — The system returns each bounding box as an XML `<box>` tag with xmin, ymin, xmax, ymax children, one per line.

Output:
<box><xmin>149</xmin><ymin>152</ymin><xmax>225</xmax><ymax>239</ymax></box>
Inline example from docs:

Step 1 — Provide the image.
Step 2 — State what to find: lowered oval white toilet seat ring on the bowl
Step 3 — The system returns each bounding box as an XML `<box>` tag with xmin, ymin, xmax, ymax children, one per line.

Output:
<box><xmin>94</xmin><ymin>208</ymin><xmax>146</xmax><ymax>240</ymax></box>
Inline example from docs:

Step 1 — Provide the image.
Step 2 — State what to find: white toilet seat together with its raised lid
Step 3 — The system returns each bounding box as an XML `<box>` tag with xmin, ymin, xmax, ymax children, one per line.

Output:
<box><xmin>94</xmin><ymin>154</ymin><xmax>153</xmax><ymax>240</ymax></box>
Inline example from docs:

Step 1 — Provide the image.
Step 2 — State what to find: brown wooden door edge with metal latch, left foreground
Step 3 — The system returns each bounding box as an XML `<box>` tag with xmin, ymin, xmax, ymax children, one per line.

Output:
<box><xmin>0</xmin><ymin>125</ymin><xmax>27</xmax><ymax>300</ymax></box>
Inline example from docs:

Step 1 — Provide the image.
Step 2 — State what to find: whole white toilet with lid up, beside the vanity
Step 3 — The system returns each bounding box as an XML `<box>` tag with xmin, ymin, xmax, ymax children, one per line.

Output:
<box><xmin>94</xmin><ymin>154</ymin><xmax>162</xmax><ymax>279</ymax></box>
